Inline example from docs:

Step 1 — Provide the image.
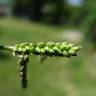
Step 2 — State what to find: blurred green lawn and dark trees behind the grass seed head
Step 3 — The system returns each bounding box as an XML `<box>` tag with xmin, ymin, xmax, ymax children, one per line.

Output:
<box><xmin>0</xmin><ymin>0</ymin><xmax>96</xmax><ymax>96</ymax></box>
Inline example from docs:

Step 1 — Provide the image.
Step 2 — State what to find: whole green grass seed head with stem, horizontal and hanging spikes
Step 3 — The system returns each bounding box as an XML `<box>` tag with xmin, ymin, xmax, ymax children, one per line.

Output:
<box><xmin>0</xmin><ymin>42</ymin><xmax>81</xmax><ymax>89</ymax></box>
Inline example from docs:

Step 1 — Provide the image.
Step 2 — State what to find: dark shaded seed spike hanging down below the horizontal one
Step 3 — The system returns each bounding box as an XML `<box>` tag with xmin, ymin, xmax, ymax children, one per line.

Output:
<box><xmin>18</xmin><ymin>55</ymin><xmax>28</xmax><ymax>89</ymax></box>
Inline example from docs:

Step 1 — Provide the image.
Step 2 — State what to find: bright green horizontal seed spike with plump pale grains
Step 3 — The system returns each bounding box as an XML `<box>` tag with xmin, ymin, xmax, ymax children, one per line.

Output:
<box><xmin>13</xmin><ymin>42</ymin><xmax>81</xmax><ymax>57</ymax></box>
